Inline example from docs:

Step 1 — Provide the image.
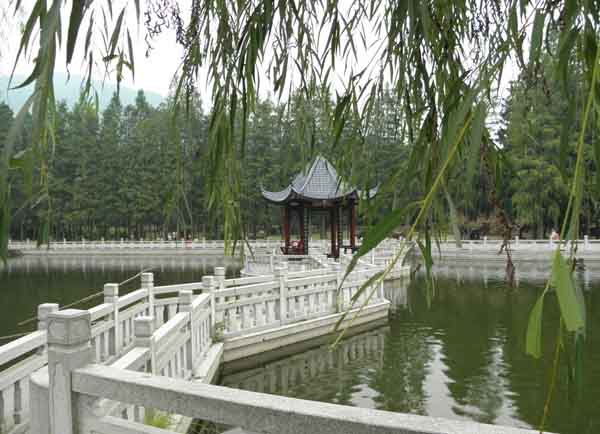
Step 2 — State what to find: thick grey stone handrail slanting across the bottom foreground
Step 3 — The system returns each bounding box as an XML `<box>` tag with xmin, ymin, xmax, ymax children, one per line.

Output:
<box><xmin>33</xmin><ymin>356</ymin><xmax>538</xmax><ymax>434</ymax></box>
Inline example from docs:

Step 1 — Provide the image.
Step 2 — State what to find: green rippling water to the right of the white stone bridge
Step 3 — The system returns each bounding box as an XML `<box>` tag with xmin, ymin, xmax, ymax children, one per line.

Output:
<box><xmin>222</xmin><ymin>265</ymin><xmax>600</xmax><ymax>434</ymax></box>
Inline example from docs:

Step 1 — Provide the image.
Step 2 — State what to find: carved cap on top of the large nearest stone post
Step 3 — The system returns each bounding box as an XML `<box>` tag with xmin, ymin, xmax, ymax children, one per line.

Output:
<box><xmin>47</xmin><ymin>309</ymin><xmax>92</xmax><ymax>345</ymax></box>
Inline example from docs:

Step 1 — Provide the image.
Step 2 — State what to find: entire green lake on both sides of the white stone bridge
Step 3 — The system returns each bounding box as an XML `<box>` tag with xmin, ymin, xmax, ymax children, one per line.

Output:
<box><xmin>0</xmin><ymin>256</ymin><xmax>600</xmax><ymax>434</ymax></box>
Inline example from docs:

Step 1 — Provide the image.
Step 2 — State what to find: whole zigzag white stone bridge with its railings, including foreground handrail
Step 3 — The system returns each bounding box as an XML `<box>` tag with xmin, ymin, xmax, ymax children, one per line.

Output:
<box><xmin>0</xmin><ymin>242</ymin><xmax>548</xmax><ymax>434</ymax></box>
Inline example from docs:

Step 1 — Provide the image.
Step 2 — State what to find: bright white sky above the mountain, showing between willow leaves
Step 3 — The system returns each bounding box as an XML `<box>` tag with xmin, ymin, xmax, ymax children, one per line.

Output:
<box><xmin>0</xmin><ymin>0</ymin><xmax>518</xmax><ymax>114</ymax></box>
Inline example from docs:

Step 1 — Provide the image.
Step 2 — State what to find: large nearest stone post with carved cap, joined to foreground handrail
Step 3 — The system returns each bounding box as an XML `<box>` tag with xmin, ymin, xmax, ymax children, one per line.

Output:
<box><xmin>46</xmin><ymin>309</ymin><xmax>92</xmax><ymax>434</ymax></box>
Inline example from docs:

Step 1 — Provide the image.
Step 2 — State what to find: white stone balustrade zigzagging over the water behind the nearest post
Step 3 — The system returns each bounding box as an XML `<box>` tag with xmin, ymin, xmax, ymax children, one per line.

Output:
<box><xmin>0</xmin><ymin>242</ymin><xmax>412</xmax><ymax>434</ymax></box>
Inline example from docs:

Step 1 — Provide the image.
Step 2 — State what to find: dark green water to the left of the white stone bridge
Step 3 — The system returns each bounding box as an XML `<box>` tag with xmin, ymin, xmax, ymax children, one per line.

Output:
<box><xmin>0</xmin><ymin>255</ymin><xmax>239</xmax><ymax>338</ymax></box>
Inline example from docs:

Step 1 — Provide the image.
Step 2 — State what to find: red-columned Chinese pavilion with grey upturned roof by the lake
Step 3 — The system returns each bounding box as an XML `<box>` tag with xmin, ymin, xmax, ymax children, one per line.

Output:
<box><xmin>262</xmin><ymin>156</ymin><xmax>377</xmax><ymax>258</ymax></box>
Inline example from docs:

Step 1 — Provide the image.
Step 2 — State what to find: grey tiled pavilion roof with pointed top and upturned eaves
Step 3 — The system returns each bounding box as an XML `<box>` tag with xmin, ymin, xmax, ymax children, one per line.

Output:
<box><xmin>262</xmin><ymin>155</ymin><xmax>377</xmax><ymax>203</ymax></box>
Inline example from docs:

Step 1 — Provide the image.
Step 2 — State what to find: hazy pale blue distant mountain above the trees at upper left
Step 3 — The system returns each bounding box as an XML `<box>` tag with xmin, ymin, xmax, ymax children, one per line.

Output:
<box><xmin>0</xmin><ymin>72</ymin><xmax>164</xmax><ymax>113</ymax></box>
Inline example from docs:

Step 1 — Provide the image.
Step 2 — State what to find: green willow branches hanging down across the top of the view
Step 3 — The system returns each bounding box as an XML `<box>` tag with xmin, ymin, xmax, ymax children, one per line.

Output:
<box><xmin>0</xmin><ymin>0</ymin><xmax>600</xmax><ymax>425</ymax></box>
